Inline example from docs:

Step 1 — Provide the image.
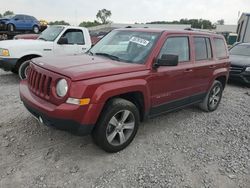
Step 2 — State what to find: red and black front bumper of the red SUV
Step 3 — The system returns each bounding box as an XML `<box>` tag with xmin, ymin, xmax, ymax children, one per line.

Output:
<box><xmin>20</xmin><ymin>81</ymin><xmax>94</xmax><ymax>135</ymax></box>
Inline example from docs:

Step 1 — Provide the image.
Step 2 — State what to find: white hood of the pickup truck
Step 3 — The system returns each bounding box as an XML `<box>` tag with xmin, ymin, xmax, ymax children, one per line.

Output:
<box><xmin>0</xmin><ymin>40</ymin><xmax>53</xmax><ymax>49</ymax></box>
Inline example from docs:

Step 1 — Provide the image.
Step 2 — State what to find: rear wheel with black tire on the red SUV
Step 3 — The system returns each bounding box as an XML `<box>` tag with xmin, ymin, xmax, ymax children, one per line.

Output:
<box><xmin>199</xmin><ymin>80</ymin><xmax>224</xmax><ymax>112</ymax></box>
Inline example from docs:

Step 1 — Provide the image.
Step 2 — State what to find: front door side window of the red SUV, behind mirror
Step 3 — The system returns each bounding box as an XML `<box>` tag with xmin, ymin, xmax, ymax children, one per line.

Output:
<box><xmin>159</xmin><ymin>37</ymin><xmax>190</xmax><ymax>62</ymax></box>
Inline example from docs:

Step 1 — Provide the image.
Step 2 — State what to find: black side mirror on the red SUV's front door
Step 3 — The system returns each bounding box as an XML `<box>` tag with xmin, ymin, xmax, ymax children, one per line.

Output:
<box><xmin>154</xmin><ymin>54</ymin><xmax>179</xmax><ymax>68</ymax></box>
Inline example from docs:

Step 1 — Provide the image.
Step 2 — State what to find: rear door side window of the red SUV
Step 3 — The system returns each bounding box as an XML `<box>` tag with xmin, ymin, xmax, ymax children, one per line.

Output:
<box><xmin>194</xmin><ymin>37</ymin><xmax>212</xmax><ymax>61</ymax></box>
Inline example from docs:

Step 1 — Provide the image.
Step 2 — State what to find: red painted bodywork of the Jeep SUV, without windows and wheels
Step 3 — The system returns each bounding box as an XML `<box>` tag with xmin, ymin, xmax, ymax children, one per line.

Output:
<box><xmin>20</xmin><ymin>29</ymin><xmax>229</xmax><ymax>134</ymax></box>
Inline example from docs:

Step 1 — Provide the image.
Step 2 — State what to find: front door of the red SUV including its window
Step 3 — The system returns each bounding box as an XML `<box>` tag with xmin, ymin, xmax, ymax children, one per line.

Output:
<box><xmin>149</xmin><ymin>35</ymin><xmax>201</xmax><ymax>116</ymax></box>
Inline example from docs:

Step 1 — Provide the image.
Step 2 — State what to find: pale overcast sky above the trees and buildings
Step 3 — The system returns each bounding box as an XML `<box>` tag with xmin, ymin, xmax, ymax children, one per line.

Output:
<box><xmin>0</xmin><ymin>0</ymin><xmax>250</xmax><ymax>25</ymax></box>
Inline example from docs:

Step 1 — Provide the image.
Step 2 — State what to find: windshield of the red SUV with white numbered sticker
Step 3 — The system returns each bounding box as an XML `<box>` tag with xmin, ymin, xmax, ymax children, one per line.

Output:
<box><xmin>89</xmin><ymin>30</ymin><xmax>159</xmax><ymax>64</ymax></box>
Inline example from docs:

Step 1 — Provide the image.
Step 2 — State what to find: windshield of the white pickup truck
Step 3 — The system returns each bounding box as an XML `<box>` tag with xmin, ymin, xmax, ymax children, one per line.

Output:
<box><xmin>38</xmin><ymin>26</ymin><xmax>64</xmax><ymax>41</ymax></box>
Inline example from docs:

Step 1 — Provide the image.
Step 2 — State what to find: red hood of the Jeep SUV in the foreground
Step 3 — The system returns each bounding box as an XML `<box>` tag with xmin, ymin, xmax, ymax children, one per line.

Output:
<box><xmin>33</xmin><ymin>55</ymin><xmax>146</xmax><ymax>81</ymax></box>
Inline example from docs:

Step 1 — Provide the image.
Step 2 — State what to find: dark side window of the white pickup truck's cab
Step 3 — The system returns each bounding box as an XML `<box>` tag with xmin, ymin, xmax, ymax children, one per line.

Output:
<box><xmin>63</xmin><ymin>29</ymin><xmax>85</xmax><ymax>45</ymax></box>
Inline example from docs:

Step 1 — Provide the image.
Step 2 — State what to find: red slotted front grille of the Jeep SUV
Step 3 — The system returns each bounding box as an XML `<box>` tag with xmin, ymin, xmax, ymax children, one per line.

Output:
<box><xmin>28</xmin><ymin>68</ymin><xmax>52</xmax><ymax>99</ymax></box>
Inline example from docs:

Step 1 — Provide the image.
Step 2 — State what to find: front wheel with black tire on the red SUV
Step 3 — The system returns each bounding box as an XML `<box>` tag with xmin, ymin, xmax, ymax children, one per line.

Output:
<box><xmin>92</xmin><ymin>98</ymin><xmax>140</xmax><ymax>153</ymax></box>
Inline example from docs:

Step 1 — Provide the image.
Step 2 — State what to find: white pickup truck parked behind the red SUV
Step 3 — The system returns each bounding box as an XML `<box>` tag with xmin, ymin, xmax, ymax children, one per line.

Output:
<box><xmin>0</xmin><ymin>26</ymin><xmax>91</xmax><ymax>79</ymax></box>
